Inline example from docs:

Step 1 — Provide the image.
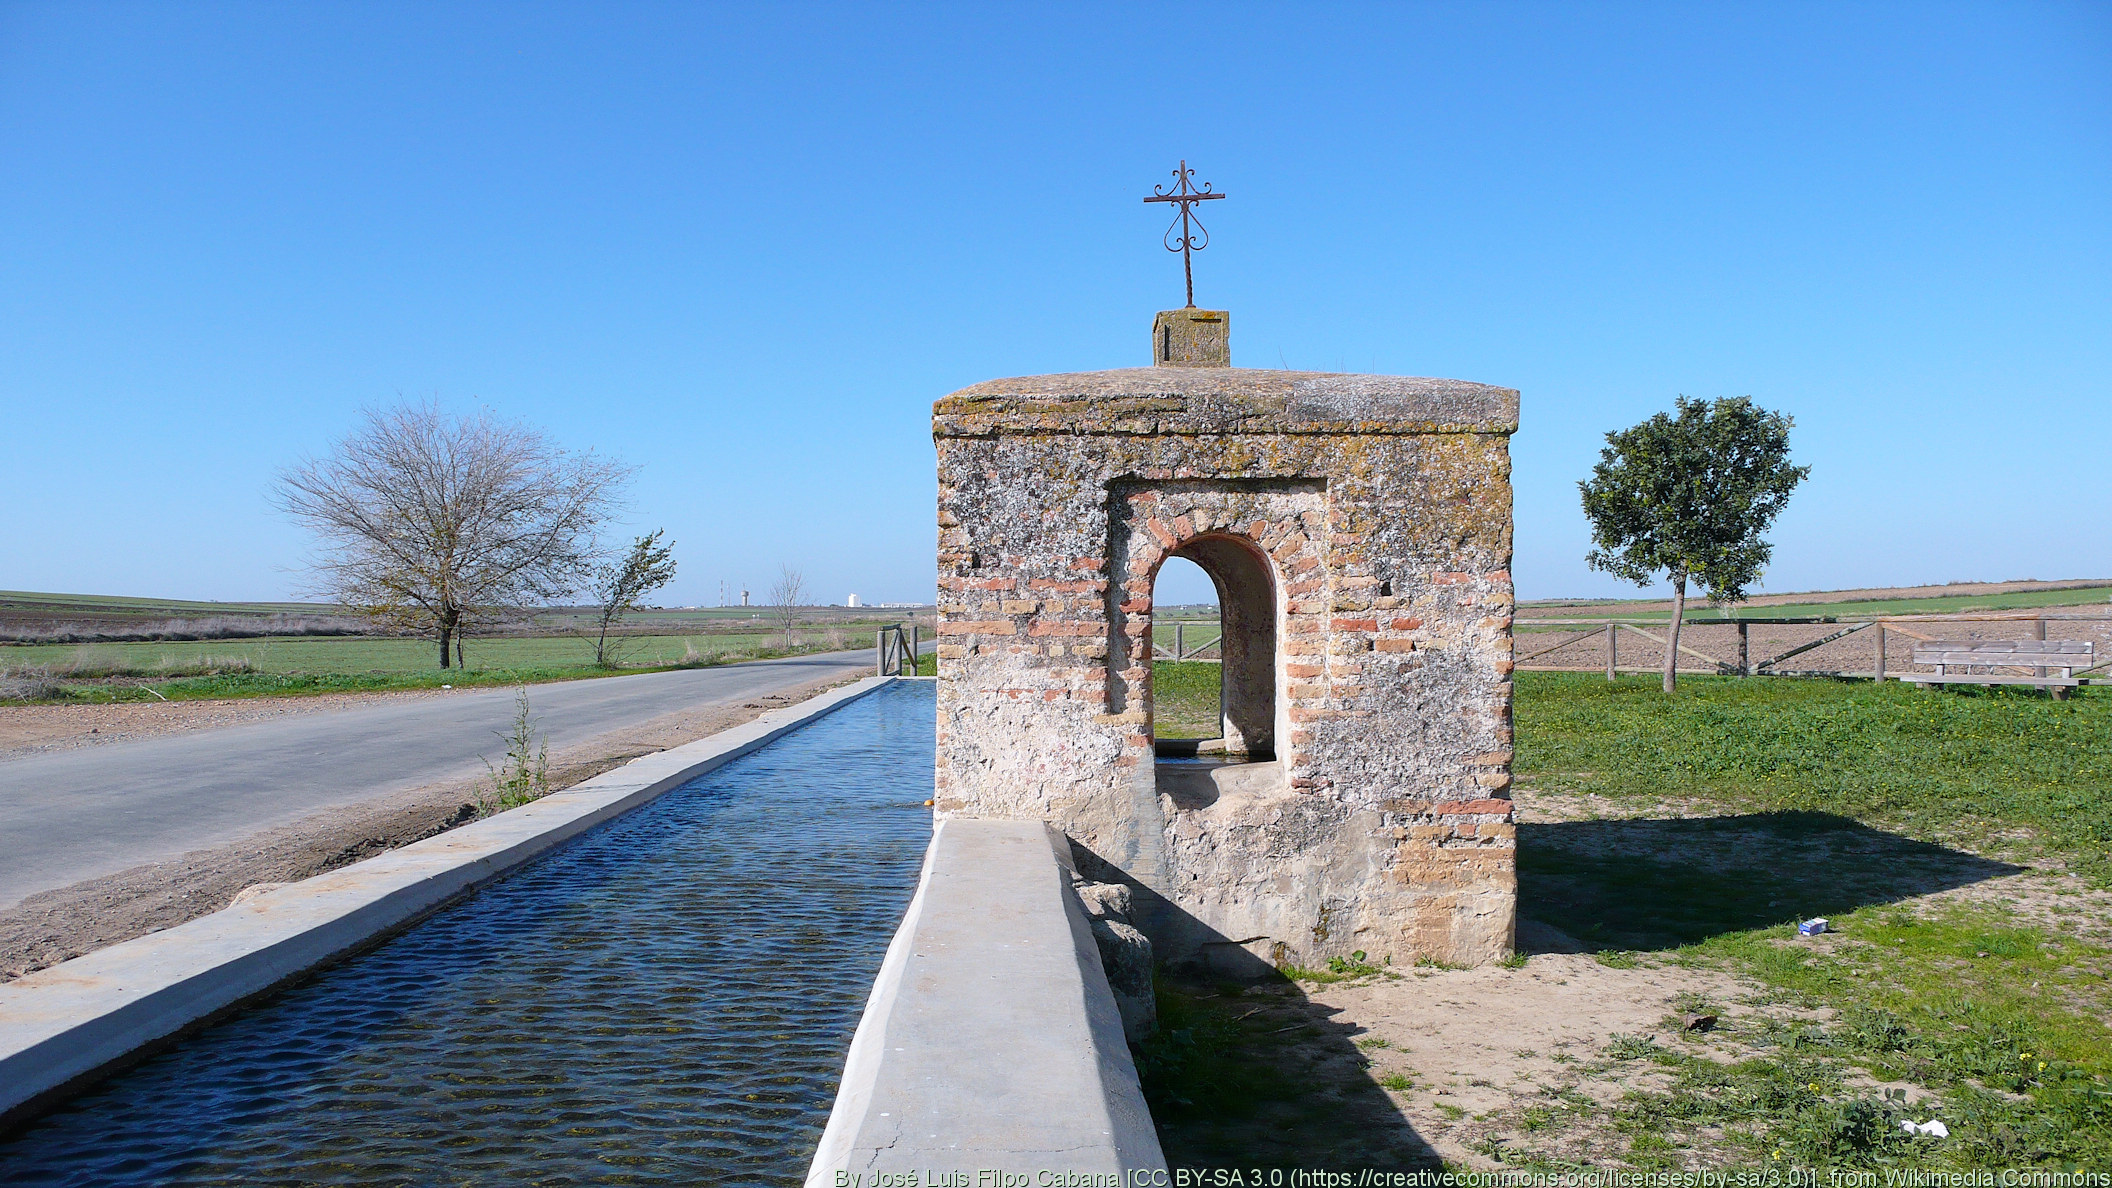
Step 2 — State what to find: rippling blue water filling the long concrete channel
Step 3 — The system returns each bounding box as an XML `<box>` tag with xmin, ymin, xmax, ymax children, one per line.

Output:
<box><xmin>0</xmin><ymin>681</ymin><xmax>934</xmax><ymax>1186</ymax></box>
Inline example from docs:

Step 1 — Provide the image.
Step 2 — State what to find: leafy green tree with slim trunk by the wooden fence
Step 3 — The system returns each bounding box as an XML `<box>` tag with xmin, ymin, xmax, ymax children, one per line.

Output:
<box><xmin>1578</xmin><ymin>395</ymin><xmax>1812</xmax><ymax>693</ymax></box>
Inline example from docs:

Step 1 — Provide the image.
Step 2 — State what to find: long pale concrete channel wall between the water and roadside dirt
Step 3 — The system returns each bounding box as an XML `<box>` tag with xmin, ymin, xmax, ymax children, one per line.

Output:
<box><xmin>0</xmin><ymin>676</ymin><xmax>895</xmax><ymax>1131</ymax></box>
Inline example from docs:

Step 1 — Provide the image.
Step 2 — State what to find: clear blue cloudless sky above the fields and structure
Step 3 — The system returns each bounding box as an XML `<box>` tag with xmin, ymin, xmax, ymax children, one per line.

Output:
<box><xmin>0</xmin><ymin>2</ymin><xmax>2112</xmax><ymax>602</ymax></box>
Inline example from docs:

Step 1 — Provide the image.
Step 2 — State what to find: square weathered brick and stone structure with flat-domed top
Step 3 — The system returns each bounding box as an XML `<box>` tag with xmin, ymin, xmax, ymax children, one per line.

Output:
<box><xmin>934</xmin><ymin>311</ymin><xmax>1519</xmax><ymax>972</ymax></box>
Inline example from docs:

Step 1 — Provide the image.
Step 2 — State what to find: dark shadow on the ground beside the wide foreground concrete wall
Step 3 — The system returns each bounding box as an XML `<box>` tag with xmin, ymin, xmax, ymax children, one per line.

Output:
<box><xmin>1136</xmin><ymin>970</ymin><xmax>1442</xmax><ymax>1182</ymax></box>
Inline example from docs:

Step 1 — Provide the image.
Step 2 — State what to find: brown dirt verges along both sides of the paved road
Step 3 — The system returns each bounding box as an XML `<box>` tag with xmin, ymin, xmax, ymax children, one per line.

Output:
<box><xmin>0</xmin><ymin>676</ymin><xmax>851</xmax><ymax>981</ymax></box>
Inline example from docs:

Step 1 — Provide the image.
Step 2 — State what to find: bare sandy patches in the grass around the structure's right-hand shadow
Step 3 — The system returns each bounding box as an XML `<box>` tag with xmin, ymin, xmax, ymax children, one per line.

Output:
<box><xmin>1208</xmin><ymin>788</ymin><xmax>2112</xmax><ymax>1169</ymax></box>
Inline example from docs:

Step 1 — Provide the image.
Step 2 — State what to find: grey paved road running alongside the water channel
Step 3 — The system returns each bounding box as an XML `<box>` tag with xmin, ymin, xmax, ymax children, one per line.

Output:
<box><xmin>0</xmin><ymin>649</ymin><xmax>872</xmax><ymax>909</ymax></box>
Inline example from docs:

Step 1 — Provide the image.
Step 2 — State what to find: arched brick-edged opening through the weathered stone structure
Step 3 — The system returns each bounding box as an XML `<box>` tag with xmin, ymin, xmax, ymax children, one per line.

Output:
<box><xmin>1151</xmin><ymin>535</ymin><xmax>1280</xmax><ymax>782</ymax></box>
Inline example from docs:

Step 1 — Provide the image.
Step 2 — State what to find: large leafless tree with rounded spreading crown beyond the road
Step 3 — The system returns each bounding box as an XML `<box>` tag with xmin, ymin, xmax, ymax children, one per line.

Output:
<box><xmin>275</xmin><ymin>402</ymin><xmax>631</xmax><ymax>668</ymax></box>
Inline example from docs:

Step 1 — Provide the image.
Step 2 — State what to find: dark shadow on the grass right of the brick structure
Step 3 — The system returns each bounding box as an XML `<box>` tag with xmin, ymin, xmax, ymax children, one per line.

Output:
<box><xmin>1519</xmin><ymin>812</ymin><xmax>2023</xmax><ymax>951</ymax></box>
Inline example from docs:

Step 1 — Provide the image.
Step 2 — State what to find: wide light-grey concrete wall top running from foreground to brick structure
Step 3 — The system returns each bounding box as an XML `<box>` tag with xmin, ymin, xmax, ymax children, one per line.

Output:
<box><xmin>807</xmin><ymin>818</ymin><xmax>1166</xmax><ymax>1188</ymax></box>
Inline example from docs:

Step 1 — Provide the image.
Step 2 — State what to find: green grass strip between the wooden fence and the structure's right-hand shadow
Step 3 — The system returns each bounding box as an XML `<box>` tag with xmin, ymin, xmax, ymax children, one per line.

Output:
<box><xmin>1514</xmin><ymin>672</ymin><xmax>2112</xmax><ymax>886</ymax></box>
